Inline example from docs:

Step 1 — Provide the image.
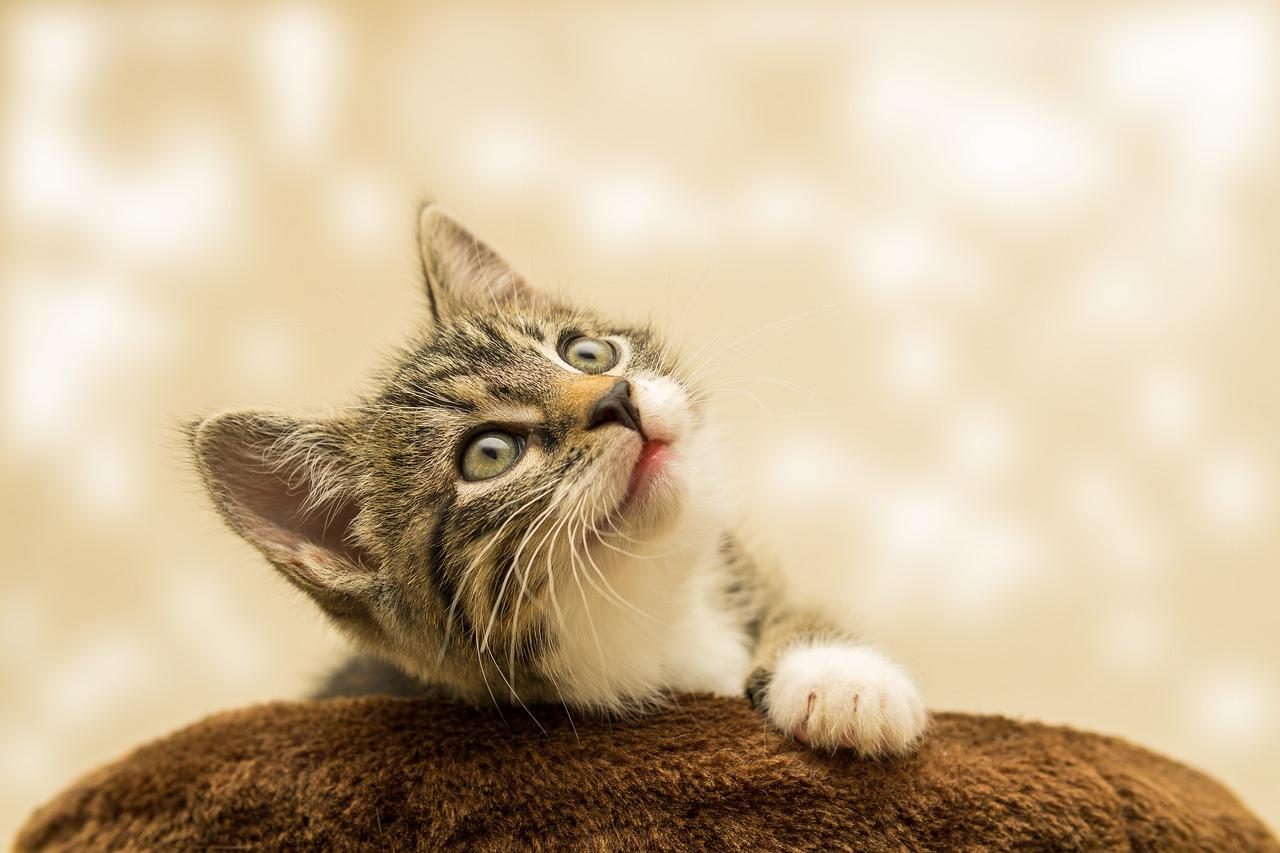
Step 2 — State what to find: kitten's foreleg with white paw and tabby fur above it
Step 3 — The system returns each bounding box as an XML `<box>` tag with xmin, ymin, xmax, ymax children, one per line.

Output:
<box><xmin>746</xmin><ymin>603</ymin><xmax>928</xmax><ymax>756</ymax></box>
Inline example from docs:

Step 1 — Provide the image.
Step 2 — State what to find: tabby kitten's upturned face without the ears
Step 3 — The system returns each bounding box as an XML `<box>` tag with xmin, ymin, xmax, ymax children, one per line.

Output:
<box><xmin>356</xmin><ymin>300</ymin><xmax>701</xmax><ymax>666</ymax></box>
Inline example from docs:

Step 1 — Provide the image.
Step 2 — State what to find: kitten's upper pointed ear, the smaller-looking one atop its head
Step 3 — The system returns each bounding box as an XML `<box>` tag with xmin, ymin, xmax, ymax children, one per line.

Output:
<box><xmin>417</xmin><ymin>202</ymin><xmax>531</xmax><ymax>320</ymax></box>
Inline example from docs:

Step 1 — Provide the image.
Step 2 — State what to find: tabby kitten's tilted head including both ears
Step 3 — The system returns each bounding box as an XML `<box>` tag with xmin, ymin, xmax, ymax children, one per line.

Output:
<box><xmin>191</xmin><ymin>206</ymin><xmax>716</xmax><ymax>699</ymax></box>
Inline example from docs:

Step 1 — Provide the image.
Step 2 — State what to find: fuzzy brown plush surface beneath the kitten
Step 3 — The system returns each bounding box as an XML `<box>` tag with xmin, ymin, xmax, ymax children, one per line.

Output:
<box><xmin>17</xmin><ymin>697</ymin><xmax>1280</xmax><ymax>852</ymax></box>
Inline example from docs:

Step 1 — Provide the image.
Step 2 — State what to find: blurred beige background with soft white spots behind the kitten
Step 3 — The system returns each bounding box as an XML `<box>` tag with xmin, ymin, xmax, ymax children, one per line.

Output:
<box><xmin>0</xmin><ymin>1</ymin><xmax>1280</xmax><ymax>838</ymax></box>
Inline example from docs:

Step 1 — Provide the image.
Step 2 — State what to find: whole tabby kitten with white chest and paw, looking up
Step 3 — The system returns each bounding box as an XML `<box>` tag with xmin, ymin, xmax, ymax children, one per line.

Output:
<box><xmin>189</xmin><ymin>205</ymin><xmax>927</xmax><ymax>754</ymax></box>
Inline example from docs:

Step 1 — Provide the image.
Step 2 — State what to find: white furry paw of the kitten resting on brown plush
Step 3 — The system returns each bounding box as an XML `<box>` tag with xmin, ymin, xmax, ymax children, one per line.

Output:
<box><xmin>764</xmin><ymin>644</ymin><xmax>928</xmax><ymax>756</ymax></box>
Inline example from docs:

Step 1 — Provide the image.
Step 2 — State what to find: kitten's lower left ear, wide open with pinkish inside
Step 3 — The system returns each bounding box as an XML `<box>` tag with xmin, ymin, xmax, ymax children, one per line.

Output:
<box><xmin>188</xmin><ymin>411</ymin><xmax>375</xmax><ymax>630</ymax></box>
